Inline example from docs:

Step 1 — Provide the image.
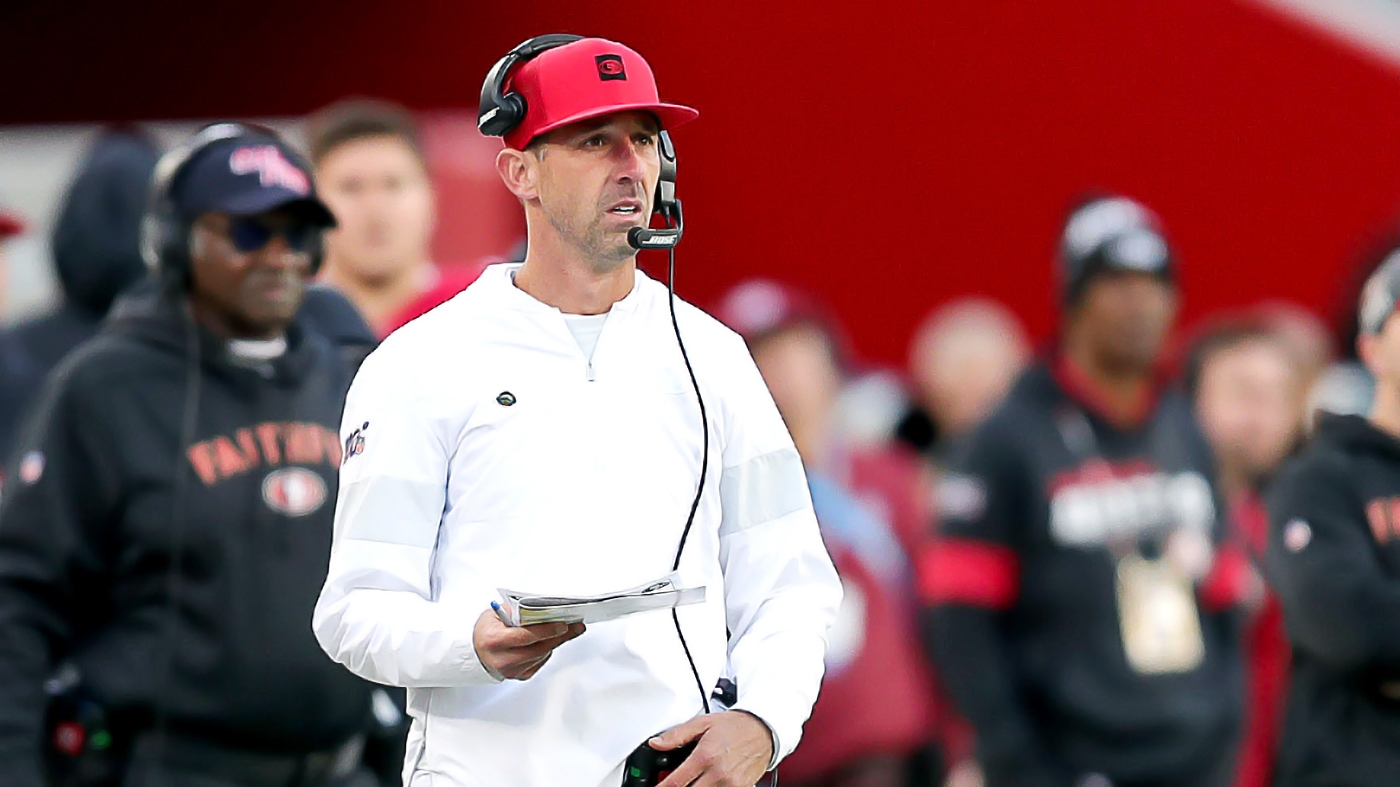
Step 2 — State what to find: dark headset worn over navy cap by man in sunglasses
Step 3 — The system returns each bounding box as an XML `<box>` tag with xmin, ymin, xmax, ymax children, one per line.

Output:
<box><xmin>141</xmin><ymin>122</ymin><xmax>325</xmax><ymax>287</ymax></box>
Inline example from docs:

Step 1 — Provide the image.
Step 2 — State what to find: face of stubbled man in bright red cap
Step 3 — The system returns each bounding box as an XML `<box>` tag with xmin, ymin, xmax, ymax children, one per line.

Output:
<box><xmin>528</xmin><ymin>112</ymin><xmax>661</xmax><ymax>272</ymax></box>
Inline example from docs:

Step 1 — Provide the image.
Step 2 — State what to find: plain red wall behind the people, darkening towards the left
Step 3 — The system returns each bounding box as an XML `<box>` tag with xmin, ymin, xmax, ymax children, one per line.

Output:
<box><xmin>0</xmin><ymin>0</ymin><xmax>1400</xmax><ymax>363</ymax></box>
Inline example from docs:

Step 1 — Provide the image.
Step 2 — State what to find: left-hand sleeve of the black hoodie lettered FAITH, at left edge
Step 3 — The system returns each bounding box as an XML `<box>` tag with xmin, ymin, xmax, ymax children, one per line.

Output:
<box><xmin>0</xmin><ymin>377</ymin><xmax>120</xmax><ymax>787</ymax></box>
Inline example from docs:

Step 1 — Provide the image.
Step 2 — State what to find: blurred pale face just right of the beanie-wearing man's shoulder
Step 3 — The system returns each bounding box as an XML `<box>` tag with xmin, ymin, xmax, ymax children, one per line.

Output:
<box><xmin>1196</xmin><ymin>337</ymin><xmax>1301</xmax><ymax>480</ymax></box>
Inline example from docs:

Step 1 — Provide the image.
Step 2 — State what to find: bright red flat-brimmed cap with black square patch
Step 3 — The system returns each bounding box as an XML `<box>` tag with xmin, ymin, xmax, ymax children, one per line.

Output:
<box><xmin>505</xmin><ymin>38</ymin><xmax>700</xmax><ymax>150</ymax></box>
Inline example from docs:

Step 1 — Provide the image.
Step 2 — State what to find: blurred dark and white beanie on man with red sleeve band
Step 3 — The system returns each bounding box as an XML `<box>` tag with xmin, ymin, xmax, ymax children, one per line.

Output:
<box><xmin>1060</xmin><ymin>196</ymin><xmax>1176</xmax><ymax>304</ymax></box>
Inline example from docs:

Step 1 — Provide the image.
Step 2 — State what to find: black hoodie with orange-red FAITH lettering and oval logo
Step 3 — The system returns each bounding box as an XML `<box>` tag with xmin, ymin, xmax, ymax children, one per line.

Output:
<box><xmin>0</xmin><ymin>282</ymin><xmax>371</xmax><ymax>787</ymax></box>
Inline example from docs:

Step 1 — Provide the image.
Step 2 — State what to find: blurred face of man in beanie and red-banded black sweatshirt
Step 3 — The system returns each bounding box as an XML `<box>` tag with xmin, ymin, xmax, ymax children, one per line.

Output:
<box><xmin>1071</xmin><ymin>272</ymin><xmax>1176</xmax><ymax>374</ymax></box>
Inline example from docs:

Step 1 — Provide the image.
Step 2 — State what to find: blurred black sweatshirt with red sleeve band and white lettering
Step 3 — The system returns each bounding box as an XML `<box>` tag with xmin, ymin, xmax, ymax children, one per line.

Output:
<box><xmin>918</xmin><ymin>363</ymin><xmax>1245</xmax><ymax>787</ymax></box>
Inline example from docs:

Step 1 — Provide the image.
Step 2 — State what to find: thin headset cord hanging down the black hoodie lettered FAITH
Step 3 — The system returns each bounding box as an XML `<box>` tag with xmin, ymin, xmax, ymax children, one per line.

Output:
<box><xmin>153</xmin><ymin>298</ymin><xmax>200</xmax><ymax>767</ymax></box>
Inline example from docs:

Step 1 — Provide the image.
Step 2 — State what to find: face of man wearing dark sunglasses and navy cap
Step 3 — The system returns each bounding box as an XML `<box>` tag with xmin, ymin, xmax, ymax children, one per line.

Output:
<box><xmin>190</xmin><ymin>209</ymin><xmax>319</xmax><ymax>339</ymax></box>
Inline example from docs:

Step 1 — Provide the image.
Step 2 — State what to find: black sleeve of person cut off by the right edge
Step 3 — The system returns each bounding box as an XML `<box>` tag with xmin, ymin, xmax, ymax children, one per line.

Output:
<box><xmin>1266</xmin><ymin>455</ymin><xmax>1400</xmax><ymax>671</ymax></box>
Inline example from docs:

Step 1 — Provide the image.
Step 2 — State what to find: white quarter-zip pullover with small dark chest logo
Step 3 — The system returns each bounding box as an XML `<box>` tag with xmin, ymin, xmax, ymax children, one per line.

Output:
<box><xmin>314</xmin><ymin>265</ymin><xmax>841</xmax><ymax>787</ymax></box>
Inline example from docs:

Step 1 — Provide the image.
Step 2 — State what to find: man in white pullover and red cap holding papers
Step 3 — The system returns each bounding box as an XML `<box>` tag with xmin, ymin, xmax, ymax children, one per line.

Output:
<box><xmin>314</xmin><ymin>36</ymin><xmax>841</xmax><ymax>787</ymax></box>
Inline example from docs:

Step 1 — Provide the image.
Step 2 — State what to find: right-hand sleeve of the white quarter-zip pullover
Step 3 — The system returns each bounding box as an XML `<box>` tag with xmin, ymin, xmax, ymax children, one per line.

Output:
<box><xmin>720</xmin><ymin>338</ymin><xmax>841</xmax><ymax>769</ymax></box>
